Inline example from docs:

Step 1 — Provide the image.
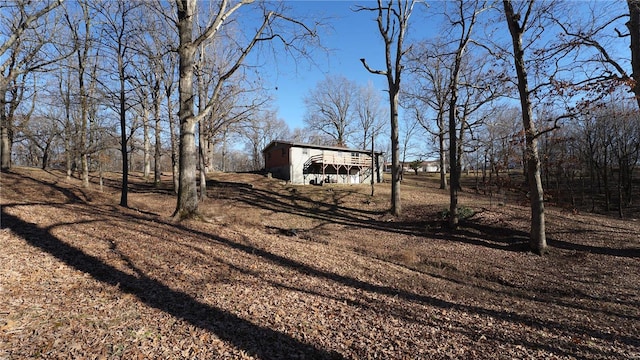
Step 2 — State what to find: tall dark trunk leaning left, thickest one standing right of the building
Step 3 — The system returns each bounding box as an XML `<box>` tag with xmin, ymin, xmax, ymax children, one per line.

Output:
<box><xmin>503</xmin><ymin>0</ymin><xmax>547</xmax><ymax>255</ymax></box>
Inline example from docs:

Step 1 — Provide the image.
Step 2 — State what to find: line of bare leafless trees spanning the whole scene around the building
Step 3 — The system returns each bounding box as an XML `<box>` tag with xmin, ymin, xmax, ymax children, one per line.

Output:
<box><xmin>0</xmin><ymin>0</ymin><xmax>640</xmax><ymax>254</ymax></box>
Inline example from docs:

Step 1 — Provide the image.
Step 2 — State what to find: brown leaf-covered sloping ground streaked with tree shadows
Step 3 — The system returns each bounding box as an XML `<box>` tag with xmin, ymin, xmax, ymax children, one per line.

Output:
<box><xmin>0</xmin><ymin>168</ymin><xmax>640</xmax><ymax>359</ymax></box>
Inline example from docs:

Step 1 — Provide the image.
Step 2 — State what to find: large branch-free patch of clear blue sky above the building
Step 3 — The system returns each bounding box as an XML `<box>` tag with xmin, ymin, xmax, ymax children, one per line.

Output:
<box><xmin>258</xmin><ymin>1</ymin><xmax>402</xmax><ymax>129</ymax></box>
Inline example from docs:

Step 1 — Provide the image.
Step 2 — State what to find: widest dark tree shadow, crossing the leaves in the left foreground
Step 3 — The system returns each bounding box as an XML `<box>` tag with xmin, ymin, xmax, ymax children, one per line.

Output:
<box><xmin>1</xmin><ymin>211</ymin><xmax>343</xmax><ymax>359</ymax></box>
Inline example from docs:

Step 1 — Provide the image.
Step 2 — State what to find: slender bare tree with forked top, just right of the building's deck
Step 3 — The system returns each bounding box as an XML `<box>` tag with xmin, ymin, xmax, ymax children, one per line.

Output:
<box><xmin>357</xmin><ymin>0</ymin><xmax>415</xmax><ymax>216</ymax></box>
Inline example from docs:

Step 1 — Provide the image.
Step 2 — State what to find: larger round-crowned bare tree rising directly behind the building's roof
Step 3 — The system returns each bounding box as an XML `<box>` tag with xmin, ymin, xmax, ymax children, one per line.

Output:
<box><xmin>304</xmin><ymin>75</ymin><xmax>358</xmax><ymax>146</ymax></box>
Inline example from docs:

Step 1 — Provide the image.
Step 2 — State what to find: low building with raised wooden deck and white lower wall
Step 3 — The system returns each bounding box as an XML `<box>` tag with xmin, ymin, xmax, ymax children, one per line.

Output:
<box><xmin>262</xmin><ymin>140</ymin><xmax>383</xmax><ymax>185</ymax></box>
